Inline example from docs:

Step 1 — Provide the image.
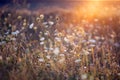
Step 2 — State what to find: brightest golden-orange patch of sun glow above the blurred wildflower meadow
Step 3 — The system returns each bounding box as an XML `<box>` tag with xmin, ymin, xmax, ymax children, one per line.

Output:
<box><xmin>74</xmin><ymin>0</ymin><xmax>115</xmax><ymax>20</ymax></box>
